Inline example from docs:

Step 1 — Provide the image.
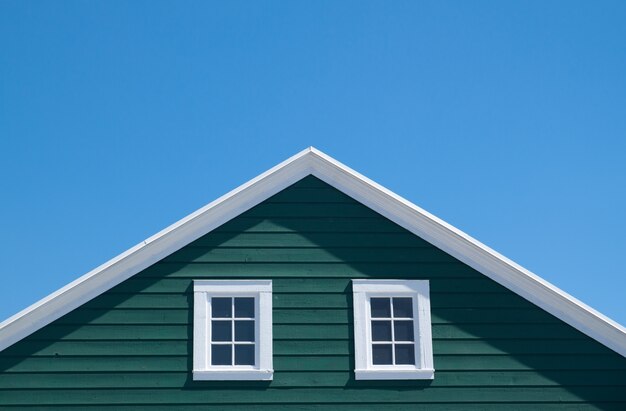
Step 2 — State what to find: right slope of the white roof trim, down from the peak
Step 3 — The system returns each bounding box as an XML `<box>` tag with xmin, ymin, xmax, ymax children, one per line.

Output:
<box><xmin>306</xmin><ymin>150</ymin><xmax>626</xmax><ymax>357</ymax></box>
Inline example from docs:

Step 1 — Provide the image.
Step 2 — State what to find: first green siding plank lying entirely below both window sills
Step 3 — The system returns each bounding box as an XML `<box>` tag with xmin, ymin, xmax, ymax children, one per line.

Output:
<box><xmin>2</xmin><ymin>387</ymin><xmax>624</xmax><ymax>405</ymax></box>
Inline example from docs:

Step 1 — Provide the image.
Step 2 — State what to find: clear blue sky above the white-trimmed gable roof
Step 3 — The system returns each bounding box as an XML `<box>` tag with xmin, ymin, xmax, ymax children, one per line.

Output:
<box><xmin>0</xmin><ymin>0</ymin><xmax>626</xmax><ymax>324</ymax></box>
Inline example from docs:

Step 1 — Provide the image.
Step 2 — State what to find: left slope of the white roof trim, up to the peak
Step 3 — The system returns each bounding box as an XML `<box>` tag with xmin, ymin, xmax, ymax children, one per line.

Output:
<box><xmin>0</xmin><ymin>147</ymin><xmax>312</xmax><ymax>351</ymax></box>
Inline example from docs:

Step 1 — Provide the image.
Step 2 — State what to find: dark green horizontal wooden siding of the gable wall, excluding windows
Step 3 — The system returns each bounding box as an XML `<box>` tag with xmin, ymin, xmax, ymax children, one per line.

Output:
<box><xmin>0</xmin><ymin>177</ymin><xmax>626</xmax><ymax>411</ymax></box>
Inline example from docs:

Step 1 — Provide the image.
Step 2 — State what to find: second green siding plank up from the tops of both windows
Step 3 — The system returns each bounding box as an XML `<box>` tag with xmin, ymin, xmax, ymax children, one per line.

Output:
<box><xmin>162</xmin><ymin>247</ymin><xmax>457</xmax><ymax>263</ymax></box>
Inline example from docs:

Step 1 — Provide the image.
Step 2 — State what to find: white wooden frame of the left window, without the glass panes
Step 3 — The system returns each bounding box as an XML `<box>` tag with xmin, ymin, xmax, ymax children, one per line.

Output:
<box><xmin>193</xmin><ymin>280</ymin><xmax>274</xmax><ymax>381</ymax></box>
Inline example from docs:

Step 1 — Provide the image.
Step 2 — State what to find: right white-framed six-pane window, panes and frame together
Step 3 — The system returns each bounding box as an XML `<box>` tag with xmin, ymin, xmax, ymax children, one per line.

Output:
<box><xmin>352</xmin><ymin>280</ymin><xmax>435</xmax><ymax>380</ymax></box>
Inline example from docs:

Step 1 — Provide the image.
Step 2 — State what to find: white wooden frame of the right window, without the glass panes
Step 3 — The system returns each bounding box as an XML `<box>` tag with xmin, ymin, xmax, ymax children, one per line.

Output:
<box><xmin>352</xmin><ymin>280</ymin><xmax>435</xmax><ymax>380</ymax></box>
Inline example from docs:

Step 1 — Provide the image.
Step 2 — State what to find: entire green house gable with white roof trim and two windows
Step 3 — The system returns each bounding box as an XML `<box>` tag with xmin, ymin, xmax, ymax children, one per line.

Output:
<box><xmin>0</xmin><ymin>148</ymin><xmax>626</xmax><ymax>411</ymax></box>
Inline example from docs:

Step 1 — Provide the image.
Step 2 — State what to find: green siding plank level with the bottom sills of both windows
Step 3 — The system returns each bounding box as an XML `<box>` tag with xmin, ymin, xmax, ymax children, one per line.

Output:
<box><xmin>0</xmin><ymin>370</ymin><xmax>626</xmax><ymax>390</ymax></box>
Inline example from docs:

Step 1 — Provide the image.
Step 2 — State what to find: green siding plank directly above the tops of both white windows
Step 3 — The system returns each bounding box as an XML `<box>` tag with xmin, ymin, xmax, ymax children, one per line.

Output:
<box><xmin>135</xmin><ymin>262</ymin><xmax>484</xmax><ymax>279</ymax></box>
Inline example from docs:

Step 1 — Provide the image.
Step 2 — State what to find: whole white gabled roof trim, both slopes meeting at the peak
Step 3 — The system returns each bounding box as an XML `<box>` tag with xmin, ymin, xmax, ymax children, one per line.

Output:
<box><xmin>0</xmin><ymin>147</ymin><xmax>626</xmax><ymax>357</ymax></box>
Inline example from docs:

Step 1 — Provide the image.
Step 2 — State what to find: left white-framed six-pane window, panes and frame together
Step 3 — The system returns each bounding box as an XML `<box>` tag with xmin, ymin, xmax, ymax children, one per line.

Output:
<box><xmin>193</xmin><ymin>280</ymin><xmax>274</xmax><ymax>380</ymax></box>
